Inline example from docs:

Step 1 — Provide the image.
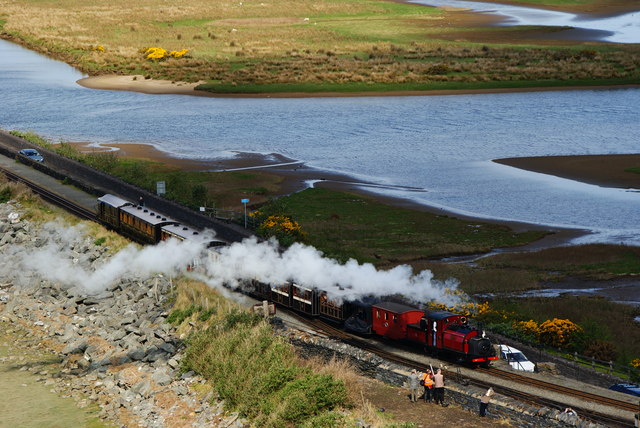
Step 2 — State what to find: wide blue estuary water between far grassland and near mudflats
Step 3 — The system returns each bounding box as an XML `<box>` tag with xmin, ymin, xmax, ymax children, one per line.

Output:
<box><xmin>0</xmin><ymin>41</ymin><xmax>640</xmax><ymax>245</ymax></box>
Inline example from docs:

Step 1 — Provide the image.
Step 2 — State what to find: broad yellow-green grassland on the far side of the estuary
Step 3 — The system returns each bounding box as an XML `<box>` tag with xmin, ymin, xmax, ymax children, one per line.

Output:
<box><xmin>0</xmin><ymin>0</ymin><xmax>640</xmax><ymax>93</ymax></box>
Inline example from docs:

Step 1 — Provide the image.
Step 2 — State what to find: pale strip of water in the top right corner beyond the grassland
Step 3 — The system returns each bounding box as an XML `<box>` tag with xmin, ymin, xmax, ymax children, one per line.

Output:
<box><xmin>410</xmin><ymin>0</ymin><xmax>640</xmax><ymax>43</ymax></box>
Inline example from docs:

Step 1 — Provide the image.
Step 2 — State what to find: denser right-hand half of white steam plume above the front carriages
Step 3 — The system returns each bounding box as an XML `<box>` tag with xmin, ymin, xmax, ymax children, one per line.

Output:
<box><xmin>205</xmin><ymin>238</ymin><xmax>458</xmax><ymax>305</ymax></box>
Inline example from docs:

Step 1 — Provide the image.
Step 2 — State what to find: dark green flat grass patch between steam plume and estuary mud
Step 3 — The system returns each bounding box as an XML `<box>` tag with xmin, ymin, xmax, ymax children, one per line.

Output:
<box><xmin>255</xmin><ymin>189</ymin><xmax>547</xmax><ymax>266</ymax></box>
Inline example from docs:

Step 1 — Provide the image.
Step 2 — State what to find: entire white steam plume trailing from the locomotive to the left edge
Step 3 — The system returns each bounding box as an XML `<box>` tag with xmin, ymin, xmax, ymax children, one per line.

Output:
<box><xmin>0</xmin><ymin>219</ymin><xmax>458</xmax><ymax>305</ymax></box>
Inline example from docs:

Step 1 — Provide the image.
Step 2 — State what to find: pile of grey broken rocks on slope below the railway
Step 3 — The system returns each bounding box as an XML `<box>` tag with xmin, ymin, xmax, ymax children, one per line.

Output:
<box><xmin>0</xmin><ymin>202</ymin><xmax>245</xmax><ymax>428</ymax></box>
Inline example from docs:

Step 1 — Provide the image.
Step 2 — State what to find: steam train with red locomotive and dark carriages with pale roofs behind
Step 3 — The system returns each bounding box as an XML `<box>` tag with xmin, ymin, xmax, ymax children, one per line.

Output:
<box><xmin>97</xmin><ymin>194</ymin><xmax>498</xmax><ymax>365</ymax></box>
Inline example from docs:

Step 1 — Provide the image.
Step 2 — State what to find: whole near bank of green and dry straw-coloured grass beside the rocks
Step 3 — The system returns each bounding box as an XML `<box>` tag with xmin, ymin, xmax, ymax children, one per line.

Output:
<box><xmin>168</xmin><ymin>281</ymin><xmax>396</xmax><ymax>427</ymax></box>
